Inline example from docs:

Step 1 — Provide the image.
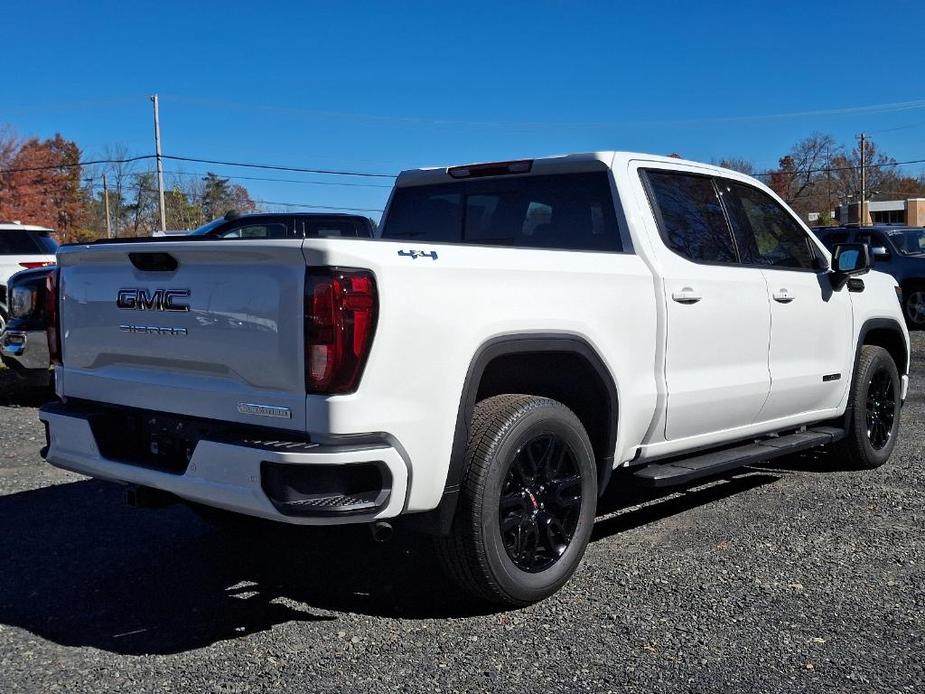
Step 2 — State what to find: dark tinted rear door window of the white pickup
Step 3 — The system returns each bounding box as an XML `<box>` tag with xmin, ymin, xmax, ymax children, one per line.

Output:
<box><xmin>645</xmin><ymin>169</ymin><xmax>737</xmax><ymax>263</ymax></box>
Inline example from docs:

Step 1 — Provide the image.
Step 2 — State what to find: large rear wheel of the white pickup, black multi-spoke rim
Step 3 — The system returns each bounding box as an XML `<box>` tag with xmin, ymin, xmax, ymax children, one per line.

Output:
<box><xmin>437</xmin><ymin>395</ymin><xmax>597</xmax><ymax>606</ymax></box>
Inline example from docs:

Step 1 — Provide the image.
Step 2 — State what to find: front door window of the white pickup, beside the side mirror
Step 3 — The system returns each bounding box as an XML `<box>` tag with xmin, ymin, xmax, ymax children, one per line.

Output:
<box><xmin>717</xmin><ymin>179</ymin><xmax>818</xmax><ymax>270</ymax></box>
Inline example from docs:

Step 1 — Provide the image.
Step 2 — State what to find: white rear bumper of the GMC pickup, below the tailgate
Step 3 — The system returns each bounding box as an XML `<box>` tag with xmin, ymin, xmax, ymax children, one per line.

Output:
<box><xmin>39</xmin><ymin>403</ymin><xmax>408</xmax><ymax>525</ymax></box>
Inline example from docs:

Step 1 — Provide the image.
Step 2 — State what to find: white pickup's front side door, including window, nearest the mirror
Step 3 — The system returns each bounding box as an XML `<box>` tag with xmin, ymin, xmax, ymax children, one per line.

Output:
<box><xmin>717</xmin><ymin>179</ymin><xmax>854</xmax><ymax>421</ymax></box>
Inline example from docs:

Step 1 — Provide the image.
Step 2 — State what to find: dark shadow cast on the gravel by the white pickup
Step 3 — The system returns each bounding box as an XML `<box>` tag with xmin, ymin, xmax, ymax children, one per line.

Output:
<box><xmin>0</xmin><ymin>473</ymin><xmax>796</xmax><ymax>655</ymax></box>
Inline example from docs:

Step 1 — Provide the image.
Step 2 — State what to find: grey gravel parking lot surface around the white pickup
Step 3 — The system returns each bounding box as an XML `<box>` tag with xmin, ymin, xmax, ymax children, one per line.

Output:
<box><xmin>0</xmin><ymin>335</ymin><xmax>925</xmax><ymax>692</ymax></box>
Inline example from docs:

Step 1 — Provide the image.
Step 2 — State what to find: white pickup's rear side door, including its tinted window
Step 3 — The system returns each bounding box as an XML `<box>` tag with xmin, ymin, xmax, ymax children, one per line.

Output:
<box><xmin>642</xmin><ymin>168</ymin><xmax>771</xmax><ymax>440</ymax></box>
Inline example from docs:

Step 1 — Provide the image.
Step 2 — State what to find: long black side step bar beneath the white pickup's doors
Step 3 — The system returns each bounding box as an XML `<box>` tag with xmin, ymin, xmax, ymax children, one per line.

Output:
<box><xmin>632</xmin><ymin>426</ymin><xmax>845</xmax><ymax>487</ymax></box>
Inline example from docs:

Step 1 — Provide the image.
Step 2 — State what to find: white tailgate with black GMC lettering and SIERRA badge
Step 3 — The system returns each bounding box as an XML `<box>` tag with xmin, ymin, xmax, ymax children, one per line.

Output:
<box><xmin>57</xmin><ymin>239</ymin><xmax>305</xmax><ymax>431</ymax></box>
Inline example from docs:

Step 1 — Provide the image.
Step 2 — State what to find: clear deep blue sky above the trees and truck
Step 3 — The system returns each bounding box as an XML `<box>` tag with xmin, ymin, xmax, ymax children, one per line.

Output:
<box><xmin>0</xmin><ymin>0</ymin><xmax>925</xmax><ymax>218</ymax></box>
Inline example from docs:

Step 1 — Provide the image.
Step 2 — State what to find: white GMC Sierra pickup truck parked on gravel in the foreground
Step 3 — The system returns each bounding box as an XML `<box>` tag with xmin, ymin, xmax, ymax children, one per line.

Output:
<box><xmin>41</xmin><ymin>152</ymin><xmax>910</xmax><ymax>604</ymax></box>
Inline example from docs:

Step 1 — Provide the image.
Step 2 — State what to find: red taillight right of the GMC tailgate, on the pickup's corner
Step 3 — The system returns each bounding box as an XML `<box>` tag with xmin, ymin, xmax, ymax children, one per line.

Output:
<box><xmin>305</xmin><ymin>267</ymin><xmax>378</xmax><ymax>395</ymax></box>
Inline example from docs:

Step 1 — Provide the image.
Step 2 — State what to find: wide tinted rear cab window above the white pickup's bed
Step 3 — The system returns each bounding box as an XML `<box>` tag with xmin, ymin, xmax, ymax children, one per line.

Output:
<box><xmin>381</xmin><ymin>171</ymin><xmax>623</xmax><ymax>252</ymax></box>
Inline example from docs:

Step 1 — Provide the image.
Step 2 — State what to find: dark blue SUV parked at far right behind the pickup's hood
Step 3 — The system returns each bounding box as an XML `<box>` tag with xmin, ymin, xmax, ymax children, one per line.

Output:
<box><xmin>813</xmin><ymin>224</ymin><xmax>925</xmax><ymax>330</ymax></box>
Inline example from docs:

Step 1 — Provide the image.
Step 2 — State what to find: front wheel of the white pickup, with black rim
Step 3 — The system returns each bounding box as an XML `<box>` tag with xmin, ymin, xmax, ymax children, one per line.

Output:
<box><xmin>835</xmin><ymin>345</ymin><xmax>902</xmax><ymax>470</ymax></box>
